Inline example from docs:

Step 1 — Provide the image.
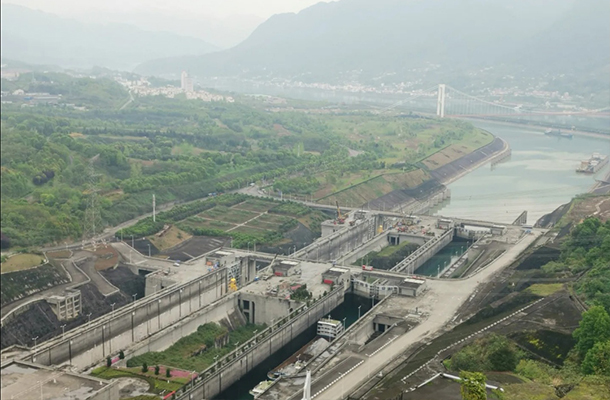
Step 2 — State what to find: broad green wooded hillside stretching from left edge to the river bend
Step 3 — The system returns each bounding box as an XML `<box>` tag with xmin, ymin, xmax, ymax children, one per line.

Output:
<box><xmin>0</xmin><ymin>74</ymin><xmax>480</xmax><ymax>247</ymax></box>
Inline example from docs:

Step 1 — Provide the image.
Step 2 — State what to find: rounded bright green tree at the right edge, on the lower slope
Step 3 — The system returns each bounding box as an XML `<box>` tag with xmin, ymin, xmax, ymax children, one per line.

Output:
<box><xmin>573</xmin><ymin>306</ymin><xmax>610</xmax><ymax>358</ymax></box>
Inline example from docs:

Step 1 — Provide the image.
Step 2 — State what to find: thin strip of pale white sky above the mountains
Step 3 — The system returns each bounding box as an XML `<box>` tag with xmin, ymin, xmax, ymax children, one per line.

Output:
<box><xmin>2</xmin><ymin>0</ymin><xmax>328</xmax><ymax>19</ymax></box>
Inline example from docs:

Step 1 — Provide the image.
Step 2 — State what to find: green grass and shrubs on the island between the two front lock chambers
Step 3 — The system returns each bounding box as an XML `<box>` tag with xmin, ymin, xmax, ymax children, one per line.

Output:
<box><xmin>127</xmin><ymin>323</ymin><xmax>264</xmax><ymax>371</ymax></box>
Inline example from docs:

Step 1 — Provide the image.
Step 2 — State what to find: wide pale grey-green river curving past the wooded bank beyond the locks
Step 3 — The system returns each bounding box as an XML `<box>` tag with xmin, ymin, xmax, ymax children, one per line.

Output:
<box><xmin>432</xmin><ymin>121</ymin><xmax>610</xmax><ymax>224</ymax></box>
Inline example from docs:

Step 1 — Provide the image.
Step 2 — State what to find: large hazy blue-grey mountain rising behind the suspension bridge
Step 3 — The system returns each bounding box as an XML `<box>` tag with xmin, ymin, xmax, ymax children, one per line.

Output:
<box><xmin>136</xmin><ymin>0</ymin><xmax>610</xmax><ymax>85</ymax></box>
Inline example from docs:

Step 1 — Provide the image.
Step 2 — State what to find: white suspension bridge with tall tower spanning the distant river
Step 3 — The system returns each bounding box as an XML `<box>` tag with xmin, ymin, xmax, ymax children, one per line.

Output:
<box><xmin>382</xmin><ymin>84</ymin><xmax>610</xmax><ymax>118</ymax></box>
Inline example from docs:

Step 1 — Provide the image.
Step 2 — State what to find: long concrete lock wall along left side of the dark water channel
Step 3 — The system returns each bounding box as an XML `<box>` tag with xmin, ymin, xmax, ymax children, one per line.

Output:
<box><xmin>179</xmin><ymin>288</ymin><xmax>344</xmax><ymax>400</ymax></box>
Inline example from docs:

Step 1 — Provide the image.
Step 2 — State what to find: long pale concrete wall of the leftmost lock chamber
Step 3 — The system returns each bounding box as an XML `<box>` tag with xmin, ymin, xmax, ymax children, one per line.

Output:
<box><xmin>27</xmin><ymin>268</ymin><xmax>228</xmax><ymax>369</ymax></box>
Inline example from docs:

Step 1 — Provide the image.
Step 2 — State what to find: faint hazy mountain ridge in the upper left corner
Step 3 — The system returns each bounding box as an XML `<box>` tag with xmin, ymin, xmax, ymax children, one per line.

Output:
<box><xmin>2</xmin><ymin>4</ymin><xmax>218</xmax><ymax>70</ymax></box>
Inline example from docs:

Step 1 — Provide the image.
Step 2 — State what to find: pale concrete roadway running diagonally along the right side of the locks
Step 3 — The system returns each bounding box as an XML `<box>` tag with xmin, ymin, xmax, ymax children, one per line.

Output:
<box><xmin>312</xmin><ymin>230</ymin><xmax>542</xmax><ymax>400</ymax></box>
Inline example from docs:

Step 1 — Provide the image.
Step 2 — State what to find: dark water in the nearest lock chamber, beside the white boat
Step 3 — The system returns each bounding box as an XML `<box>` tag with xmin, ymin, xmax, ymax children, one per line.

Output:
<box><xmin>215</xmin><ymin>293</ymin><xmax>372</xmax><ymax>400</ymax></box>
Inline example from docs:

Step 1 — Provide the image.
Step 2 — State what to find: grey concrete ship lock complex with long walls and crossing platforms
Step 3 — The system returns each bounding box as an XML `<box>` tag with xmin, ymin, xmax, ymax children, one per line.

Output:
<box><xmin>1</xmin><ymin>211</ymin><xmax>522</xmax><ymax>399</ymax></box>
